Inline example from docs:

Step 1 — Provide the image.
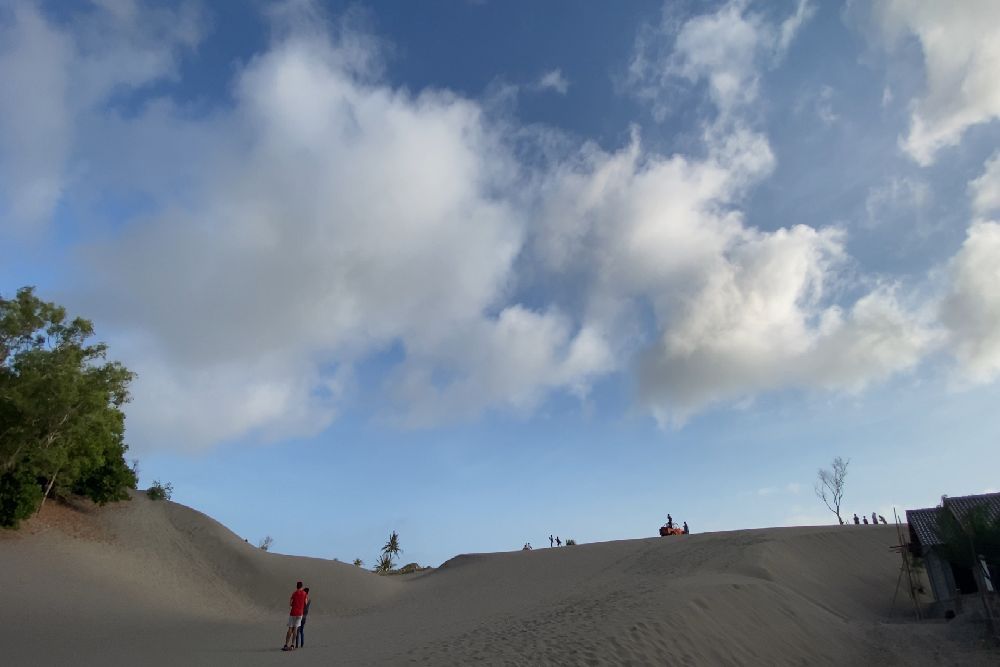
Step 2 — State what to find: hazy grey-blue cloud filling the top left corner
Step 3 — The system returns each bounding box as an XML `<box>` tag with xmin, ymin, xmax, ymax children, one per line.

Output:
<box><xmin>0</xmin><ymin>0</ymin><xmax>202</xmax><ymax>228</ymax></box>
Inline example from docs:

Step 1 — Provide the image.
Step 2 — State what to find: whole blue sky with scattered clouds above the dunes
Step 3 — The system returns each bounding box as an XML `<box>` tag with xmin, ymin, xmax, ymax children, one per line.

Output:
<box><xmin>0</xmin><ymin>0</ymin><xmax>1000</xmax><ymax>565</ymax></box>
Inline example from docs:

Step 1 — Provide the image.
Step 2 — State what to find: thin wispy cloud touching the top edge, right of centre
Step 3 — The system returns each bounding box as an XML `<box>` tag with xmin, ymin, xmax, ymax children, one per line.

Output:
<box><xmin>628</xmin><ymin>0</ymin><xmax>813</xmax><ymax>119</ymax></box>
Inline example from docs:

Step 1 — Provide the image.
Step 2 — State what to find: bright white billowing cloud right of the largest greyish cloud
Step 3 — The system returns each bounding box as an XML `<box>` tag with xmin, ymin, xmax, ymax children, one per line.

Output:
<box><xmin>534</xmin><ymin>126</ymin><xmax>934</xmax><ymax>423</ymax></box>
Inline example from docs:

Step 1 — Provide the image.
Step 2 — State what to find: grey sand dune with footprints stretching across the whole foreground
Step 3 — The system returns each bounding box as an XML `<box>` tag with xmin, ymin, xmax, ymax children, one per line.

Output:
<box><xmin>0</xmin><ymin>495</ymin><xmax>1000</xmax><ymax>665</ymax></box>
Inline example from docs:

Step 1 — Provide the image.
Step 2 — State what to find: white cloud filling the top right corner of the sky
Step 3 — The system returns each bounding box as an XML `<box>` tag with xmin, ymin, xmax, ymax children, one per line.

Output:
<box><xmin>873</xmin><ymin>0</ymin><xmax>1000</xmax><ymax>165</ymax></box>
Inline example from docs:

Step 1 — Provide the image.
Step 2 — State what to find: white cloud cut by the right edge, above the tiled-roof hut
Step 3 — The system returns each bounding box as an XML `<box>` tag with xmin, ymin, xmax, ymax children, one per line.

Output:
<box><xmin>940</xmin><ymin>220</ymin><xmax>1000</xmax><ymax>383</ymax></box>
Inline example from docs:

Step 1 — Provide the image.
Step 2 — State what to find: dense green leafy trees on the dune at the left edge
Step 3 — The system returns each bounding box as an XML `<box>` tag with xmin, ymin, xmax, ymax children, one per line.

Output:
<box><xmin>0</xmin><ymin>287</ymin><xmax>136</xmax><ymax>526</ymax></box>
